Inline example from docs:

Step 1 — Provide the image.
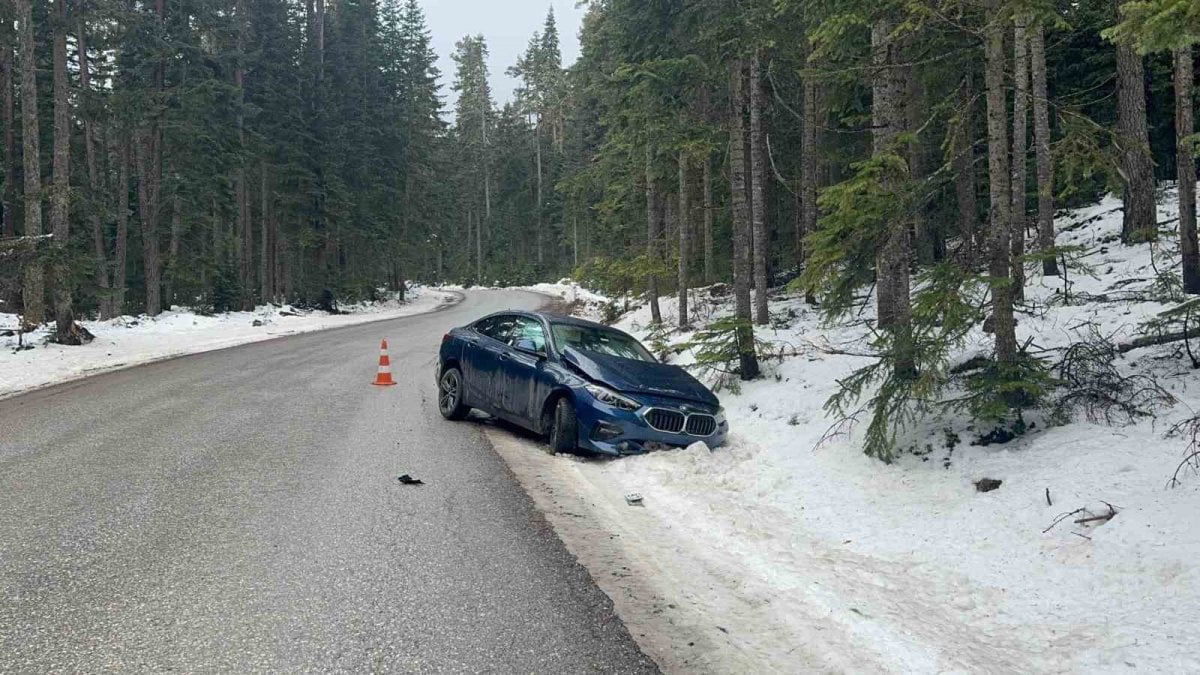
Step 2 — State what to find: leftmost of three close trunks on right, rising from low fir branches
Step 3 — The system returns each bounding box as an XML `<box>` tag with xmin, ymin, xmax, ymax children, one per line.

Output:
<box><xmin>984</xmin><ymin>0</ymin><xmax>1016</xmax><ymax>364</ymax></box>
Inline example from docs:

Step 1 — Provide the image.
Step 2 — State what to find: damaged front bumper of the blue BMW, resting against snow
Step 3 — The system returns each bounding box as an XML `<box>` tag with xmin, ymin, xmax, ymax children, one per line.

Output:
<box><xmin>575</xmin><ymin>392</ymin><xmax>730</xmax><ymax>456</ymax></box>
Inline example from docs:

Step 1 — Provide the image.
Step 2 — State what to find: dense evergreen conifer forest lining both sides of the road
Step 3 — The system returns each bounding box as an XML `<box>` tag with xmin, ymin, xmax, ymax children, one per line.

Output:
<box><xmin>0</xmin><ymin>0</ymin><xmax>1200</xmax><ymax>456</ymax></box>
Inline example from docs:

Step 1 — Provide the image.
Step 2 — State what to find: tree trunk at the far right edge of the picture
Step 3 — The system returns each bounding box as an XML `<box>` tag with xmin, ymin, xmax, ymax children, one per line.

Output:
<box><xmin>1175</xmin><ymin>47</ymin><xmax>1200</xmax><ymax>294</ymax></box>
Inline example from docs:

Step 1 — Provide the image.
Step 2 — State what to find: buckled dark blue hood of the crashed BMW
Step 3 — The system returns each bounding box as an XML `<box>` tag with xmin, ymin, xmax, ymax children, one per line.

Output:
<box><xmin>563</xmin><ymin>348</ymin><xmax>720</xmax><ymax>407</ymax></box>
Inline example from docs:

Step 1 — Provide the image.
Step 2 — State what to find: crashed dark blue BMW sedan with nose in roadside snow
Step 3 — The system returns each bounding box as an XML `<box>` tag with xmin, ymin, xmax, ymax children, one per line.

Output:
<box><xmin>437</xmin><ymin>311</ymin><xmax>728</xmax><ymax>455</ymax></box>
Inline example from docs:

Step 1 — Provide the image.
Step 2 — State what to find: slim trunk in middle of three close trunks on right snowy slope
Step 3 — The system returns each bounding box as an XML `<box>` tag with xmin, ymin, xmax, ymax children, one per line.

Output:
<box><xmin>1009</xmin><ymin>12</ymin><xmax>1030</xmax><ymax>303</ymax></box>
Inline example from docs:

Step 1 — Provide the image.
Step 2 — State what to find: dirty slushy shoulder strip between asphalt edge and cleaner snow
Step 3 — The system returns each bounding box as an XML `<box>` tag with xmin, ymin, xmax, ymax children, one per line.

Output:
<box><xmin>486</xmin><ymin>428</ymin><xmax>849</xmax><ymax>673</ymax></box>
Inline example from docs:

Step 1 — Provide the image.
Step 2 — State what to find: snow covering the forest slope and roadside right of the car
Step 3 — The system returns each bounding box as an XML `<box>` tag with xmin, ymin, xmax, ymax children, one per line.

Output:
<box><xmin>494</xmin><ymin>186</ymin><xmax>1200</xmax><ymax>673</ymax></box>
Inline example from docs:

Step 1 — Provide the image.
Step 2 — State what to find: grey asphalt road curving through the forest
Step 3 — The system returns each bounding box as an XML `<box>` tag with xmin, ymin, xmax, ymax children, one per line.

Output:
<box><xmin>0</xmin><ymin>292</ymin><xmax>655</xmax><ymax>673</ymax></box>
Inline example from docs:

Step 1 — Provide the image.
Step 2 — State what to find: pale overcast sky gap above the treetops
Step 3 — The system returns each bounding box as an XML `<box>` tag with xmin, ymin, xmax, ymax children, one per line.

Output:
<box><xmin>421</xmin><ymin>0</ymin><xmax>586</xmax><ymax>117</ymax></box>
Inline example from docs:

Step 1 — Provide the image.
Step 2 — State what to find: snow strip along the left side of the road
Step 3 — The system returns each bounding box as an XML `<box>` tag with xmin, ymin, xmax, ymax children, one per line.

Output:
<box><xmin>0</xmin><ymin>286</ymin><xmax>457</xmax><ymax>398</ymax></box>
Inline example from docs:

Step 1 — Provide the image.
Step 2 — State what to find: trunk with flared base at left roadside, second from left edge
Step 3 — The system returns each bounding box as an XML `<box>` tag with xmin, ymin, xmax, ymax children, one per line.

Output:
<box><xmin>50</xmin><ymin>0</ymin><xmax>76</xmax><ymax>345</ymax></box>
